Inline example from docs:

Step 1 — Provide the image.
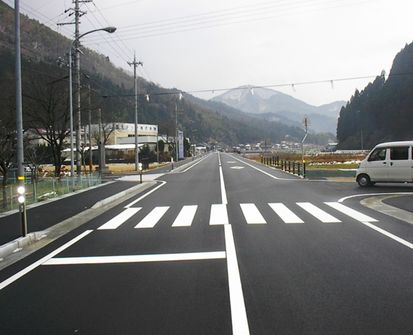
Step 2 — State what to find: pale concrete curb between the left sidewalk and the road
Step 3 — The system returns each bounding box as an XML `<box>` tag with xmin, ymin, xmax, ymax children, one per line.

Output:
<box><xmin>0</xmin><ymin>182</ymin><xmax>156</xmax><ymax>270</ymax></box>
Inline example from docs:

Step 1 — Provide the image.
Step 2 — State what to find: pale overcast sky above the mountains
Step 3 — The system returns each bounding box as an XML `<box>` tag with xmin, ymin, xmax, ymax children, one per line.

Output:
<box><xmin>3</xmin><ymin>0</ymin><xmax>413</xmax><ymax>105</ymax></box>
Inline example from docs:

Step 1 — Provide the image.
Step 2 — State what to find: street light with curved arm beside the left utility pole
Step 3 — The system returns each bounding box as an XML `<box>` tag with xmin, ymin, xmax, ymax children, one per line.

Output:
<box><xmin>69</xmin><ymin>27</ymin><xmax>116</xmax><ymax>182</ymax></box>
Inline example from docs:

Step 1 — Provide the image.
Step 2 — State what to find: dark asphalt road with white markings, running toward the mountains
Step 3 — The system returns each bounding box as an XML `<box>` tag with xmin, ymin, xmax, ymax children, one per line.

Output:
<box><xmin>0</xmin><ymin>153</ymin><xmax>413</xmax><ymax>335</ymax></box>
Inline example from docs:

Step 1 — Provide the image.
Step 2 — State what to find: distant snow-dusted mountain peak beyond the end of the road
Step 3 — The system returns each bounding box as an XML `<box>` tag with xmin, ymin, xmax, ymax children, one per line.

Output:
<box><xmin>212</xmin><ymin>86</ymin><xmax>345</xmax><ymax>133</ymax></box>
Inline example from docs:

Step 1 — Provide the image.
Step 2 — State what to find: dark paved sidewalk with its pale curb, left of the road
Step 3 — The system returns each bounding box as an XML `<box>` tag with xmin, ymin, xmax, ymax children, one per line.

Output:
<box><xmin>0</xmin><ymin>159</ymin><xmax>203</xmax><ymax>261</ymax></box>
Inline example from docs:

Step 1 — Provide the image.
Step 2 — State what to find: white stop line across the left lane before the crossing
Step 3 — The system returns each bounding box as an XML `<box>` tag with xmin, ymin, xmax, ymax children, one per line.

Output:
<box><xmin>43</xmin><ymin>251</ymin><xmax>226</xmax><ymax>265</ymax></box>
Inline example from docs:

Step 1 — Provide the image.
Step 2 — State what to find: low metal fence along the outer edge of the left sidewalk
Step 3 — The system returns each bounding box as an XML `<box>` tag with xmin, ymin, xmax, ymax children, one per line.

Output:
<box><xmin>0</xmin><ymin>174</ymin><xmax>102</xmax><ymax>212</ymax></box>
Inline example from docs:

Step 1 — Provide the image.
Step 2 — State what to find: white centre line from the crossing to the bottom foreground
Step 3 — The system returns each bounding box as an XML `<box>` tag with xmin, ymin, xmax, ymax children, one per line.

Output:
<box><xmin>224</xmin><ymin>225</ymin><xmax>250</xmax><ymax>335</ymax></box>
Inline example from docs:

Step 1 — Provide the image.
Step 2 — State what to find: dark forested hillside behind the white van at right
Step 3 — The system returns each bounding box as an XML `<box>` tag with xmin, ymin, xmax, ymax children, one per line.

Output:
<box><xmin>337</xmin><ymin>43</ymin><xmax>413</xmax><ymax>149</ymax></box>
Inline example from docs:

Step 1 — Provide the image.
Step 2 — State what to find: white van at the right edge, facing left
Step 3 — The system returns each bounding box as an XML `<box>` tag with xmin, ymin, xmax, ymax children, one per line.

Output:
<box><xmin>356</xmin><ymin>141</ymin><xmax>413</xmax><ymax>187</ymax></box>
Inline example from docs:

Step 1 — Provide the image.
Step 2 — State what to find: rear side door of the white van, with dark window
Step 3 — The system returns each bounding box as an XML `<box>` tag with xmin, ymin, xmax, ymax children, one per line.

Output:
<box><xmin>388</xmin><ymin>146</ymin><xmax>413</xmax><ymax>182</ymax></box>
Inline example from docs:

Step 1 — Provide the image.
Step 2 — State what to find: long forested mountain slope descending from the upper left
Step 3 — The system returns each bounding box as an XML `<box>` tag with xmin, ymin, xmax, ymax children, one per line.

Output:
<box><xmin>0</xmin><ymin>1</ymin><xmax>334</xmax><ymax>145</ymax></box>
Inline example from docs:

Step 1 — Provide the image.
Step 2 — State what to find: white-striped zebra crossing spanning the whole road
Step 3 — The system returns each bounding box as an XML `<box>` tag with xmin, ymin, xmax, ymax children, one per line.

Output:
<box><xmin>98</xmin><ymin>202</ymin><xmax>377</xmax><ymax>230</ymax></box>
